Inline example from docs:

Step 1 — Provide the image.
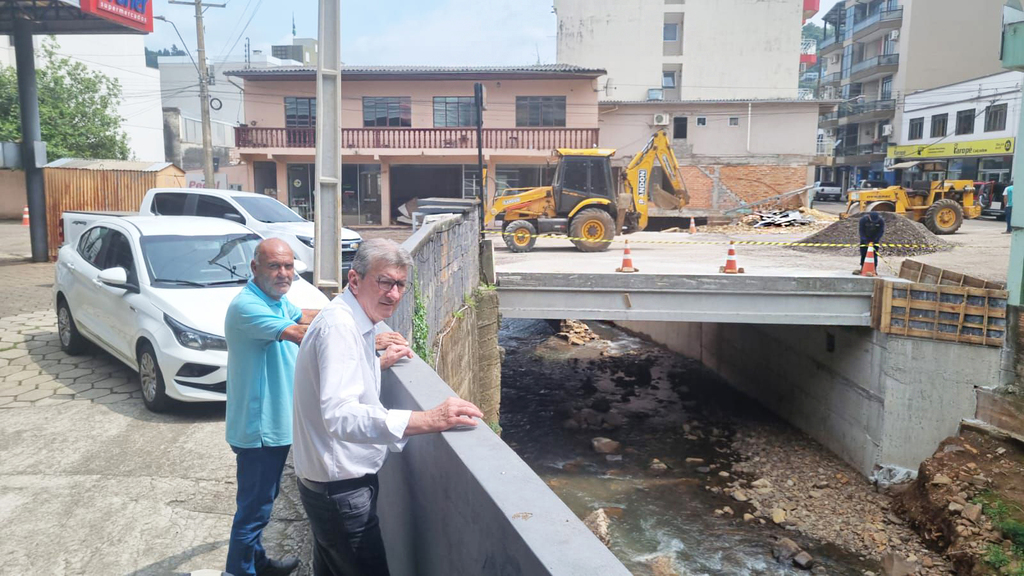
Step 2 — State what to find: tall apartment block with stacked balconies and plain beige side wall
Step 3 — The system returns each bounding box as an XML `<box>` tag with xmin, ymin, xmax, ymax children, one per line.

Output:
<box><xmin>818</xmin><ymin>0</ymin><xmax>1004</xmax><ymax>187</ymax></box>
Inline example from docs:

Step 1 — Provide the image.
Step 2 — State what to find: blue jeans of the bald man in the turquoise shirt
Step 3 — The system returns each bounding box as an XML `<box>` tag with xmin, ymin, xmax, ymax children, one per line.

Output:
<box><xmin>224</xmin><ymin>445</ymin><xmax>291</xmax><ymax>576</ymax></box>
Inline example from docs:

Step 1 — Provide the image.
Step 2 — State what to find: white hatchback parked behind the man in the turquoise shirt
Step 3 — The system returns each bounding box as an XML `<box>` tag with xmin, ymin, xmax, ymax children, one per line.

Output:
<box><xmin>53</xmin><ymin>216</ymin><xmax>328</xmax><ymax>411</ymax></box>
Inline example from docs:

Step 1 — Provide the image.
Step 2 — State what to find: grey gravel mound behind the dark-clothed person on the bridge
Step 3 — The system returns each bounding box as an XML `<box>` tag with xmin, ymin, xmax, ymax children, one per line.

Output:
<box><xmin>794</xmin><ymin>212</ymin><xmax>952</xmax><ymax>256</ymax></box>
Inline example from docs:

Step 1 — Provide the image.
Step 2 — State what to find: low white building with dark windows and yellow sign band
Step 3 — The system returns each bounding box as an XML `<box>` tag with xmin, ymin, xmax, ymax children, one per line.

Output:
<box><xmin>887</xmin><ymin>72</ymin><xmax>1024</xmax><ymax>183</ymax></box>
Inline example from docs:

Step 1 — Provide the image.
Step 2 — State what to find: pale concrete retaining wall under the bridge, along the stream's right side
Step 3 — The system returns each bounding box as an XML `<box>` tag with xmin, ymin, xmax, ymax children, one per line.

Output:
<box><xmin>620</xmin><ymin>322</ymin><xmax>1000</xmax><ymax>476</ymax></box>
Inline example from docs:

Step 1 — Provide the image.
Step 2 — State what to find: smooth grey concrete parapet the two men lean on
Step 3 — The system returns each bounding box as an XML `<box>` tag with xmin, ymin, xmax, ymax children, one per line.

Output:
<box><xmin>378</xmin><ymin>359</ymin><xmax>629</xmax><ymax>576</ymax></box>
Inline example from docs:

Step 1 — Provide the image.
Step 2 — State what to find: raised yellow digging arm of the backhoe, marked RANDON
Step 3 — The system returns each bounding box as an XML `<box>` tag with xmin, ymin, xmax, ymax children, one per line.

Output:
<box><xmin>625</xmin><ymin>130</ymin><xmax>690</xmax><ymax>230</ymax></box>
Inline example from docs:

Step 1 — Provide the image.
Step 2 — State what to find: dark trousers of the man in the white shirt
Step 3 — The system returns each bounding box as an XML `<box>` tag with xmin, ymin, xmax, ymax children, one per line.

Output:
<box><xmin>298</xmin><ymin>476</ymin><xmax>390</xmax><ymax>576</ymax></box>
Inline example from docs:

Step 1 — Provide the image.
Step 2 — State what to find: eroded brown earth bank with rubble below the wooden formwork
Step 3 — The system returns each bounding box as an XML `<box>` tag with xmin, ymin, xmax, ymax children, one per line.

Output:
<box><xmin>896</xmin><ymin>431</ymin><xmax>1024</xmax><ymax>575</ymax></box>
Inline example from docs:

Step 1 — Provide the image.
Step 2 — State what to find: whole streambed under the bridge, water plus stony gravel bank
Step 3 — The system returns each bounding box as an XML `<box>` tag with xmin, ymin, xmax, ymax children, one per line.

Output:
<box><xmin>501</xmin><ymin>321</ymin><xmax>929</xmax><ymax>575</ymax></box>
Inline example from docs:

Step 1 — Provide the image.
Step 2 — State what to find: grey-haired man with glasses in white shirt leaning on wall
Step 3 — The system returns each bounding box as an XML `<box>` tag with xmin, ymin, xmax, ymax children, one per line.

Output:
<box><xmin>292</xmin><ymin>239</ymin><xmax>483</xmax><ymax>576</ymax></box>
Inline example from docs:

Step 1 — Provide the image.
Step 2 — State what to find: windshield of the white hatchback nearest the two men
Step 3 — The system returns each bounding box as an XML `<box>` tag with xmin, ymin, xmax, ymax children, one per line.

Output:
<box><xmin>141</xmin><ymin>234</ymin><xmax>262</xmax><ymax>287</ymax></box>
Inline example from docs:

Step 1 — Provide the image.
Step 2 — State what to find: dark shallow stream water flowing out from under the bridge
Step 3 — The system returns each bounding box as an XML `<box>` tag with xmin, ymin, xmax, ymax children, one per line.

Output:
<box><xmin>500</xmin><ymin>320</ymin><xmax>878</xmax><ymax>576</ymax></box>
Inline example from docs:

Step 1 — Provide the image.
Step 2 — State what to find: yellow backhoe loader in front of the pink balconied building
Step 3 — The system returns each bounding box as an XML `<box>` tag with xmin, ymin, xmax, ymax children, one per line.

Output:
<box><xmin>484</xmin><ymin>130</ymin><xmax>689</xmax><ymax>252</ymax></box>
